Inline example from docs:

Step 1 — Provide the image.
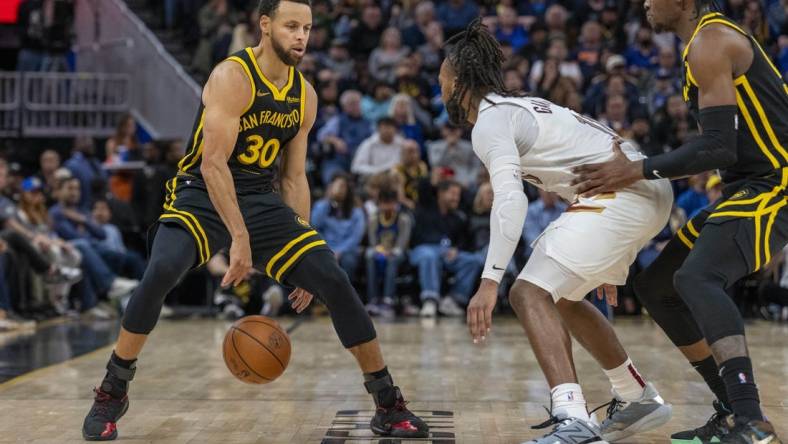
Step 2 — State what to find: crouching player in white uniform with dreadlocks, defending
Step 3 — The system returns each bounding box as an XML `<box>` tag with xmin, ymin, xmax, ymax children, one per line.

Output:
<box><xmin>439</xmin><ymin>20</ymin><xmax>673</xmax><ymax>444</ymax></box>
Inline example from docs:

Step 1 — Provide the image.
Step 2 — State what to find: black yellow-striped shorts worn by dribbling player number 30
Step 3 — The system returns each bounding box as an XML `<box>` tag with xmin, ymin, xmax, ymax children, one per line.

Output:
<box><xmin>159</xmin><ymin>175</ymin><xmax>328</xmax><ymax>282</ymax></box>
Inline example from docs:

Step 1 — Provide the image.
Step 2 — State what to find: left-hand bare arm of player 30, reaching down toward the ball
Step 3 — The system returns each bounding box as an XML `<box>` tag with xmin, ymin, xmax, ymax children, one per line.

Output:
<box><xmin>200</xmin><ymin>62</ymin><xmax>252</xmax><ymax>286</ymax></box>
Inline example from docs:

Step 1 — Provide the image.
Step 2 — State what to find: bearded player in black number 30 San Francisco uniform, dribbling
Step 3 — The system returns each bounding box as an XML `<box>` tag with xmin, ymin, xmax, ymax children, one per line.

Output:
<box><xmin>82</xmin><ymin>0</ymin><xmax>428</xmax><ymax>441</ymax></box>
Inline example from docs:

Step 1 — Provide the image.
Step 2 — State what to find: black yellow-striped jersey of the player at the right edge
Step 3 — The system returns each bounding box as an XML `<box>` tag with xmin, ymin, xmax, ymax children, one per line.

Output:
<box><xmin>682</xmin><ymin>12</ymin><xmax>788</xmax><ymax>183</ymax></box>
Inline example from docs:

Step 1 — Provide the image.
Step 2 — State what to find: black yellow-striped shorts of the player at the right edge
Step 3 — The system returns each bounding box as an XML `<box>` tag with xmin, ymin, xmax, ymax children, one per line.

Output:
<box><xmin>676</xmin><ymin>168</ymin><xmax>788</xmax><ymax>272</ymax></box>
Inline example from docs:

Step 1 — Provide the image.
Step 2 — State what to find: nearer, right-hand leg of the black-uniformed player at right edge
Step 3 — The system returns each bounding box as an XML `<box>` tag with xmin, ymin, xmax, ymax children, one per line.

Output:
<box><xmin>674</xmin><ymin>211</ymin><xmax>788</xmax><ymax>442</ymax></box>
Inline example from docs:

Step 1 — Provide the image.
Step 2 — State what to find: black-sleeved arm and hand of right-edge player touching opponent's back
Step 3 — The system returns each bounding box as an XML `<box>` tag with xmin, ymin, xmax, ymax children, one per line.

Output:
<box><xmin>574</xmin><ymin>25</ymin><xmax>752</xmax><ymax>196</ymax></box>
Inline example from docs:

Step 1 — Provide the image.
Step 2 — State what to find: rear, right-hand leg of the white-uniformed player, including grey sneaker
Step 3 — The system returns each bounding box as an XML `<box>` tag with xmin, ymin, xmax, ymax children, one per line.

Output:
<box><xmin>556</xmin><ymin>296</ymin><xmax>672</xmax><ymax>441</ymax></box>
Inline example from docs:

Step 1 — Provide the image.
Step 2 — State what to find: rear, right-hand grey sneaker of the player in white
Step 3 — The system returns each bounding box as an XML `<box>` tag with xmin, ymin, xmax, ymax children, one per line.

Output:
<box><xmin>592</xmin><ymin>382</ymin><xmax>673</xmax><ymax>442</ymax></box>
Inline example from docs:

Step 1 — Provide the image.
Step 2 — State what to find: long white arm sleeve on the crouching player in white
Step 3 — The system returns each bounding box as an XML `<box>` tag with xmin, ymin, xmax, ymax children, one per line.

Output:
<box><xmin>472</xmin><ymin>105</ymin><xmax>528</xmax><ymax>282</ymax></box>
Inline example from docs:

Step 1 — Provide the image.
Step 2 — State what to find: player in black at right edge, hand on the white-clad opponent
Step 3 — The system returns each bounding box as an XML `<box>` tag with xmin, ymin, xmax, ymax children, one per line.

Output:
<box><xmin>576</xmin><ymin>0</ymin><xmax>788</xmax><ymax>444</ymax></box>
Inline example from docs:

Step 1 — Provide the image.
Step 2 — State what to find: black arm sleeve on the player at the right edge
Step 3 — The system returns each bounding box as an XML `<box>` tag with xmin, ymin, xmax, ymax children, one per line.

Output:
<box><xmin>643</xmin><ymin>105</ymin><xmax>738</xmax><ymax>180</ymax></box>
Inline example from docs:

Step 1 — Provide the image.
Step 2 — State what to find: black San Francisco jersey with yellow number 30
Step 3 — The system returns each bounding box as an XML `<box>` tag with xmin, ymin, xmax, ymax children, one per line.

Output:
<box><xmin>178</xmin><ymin>48</ymin><xmax>306</xmax><ymax>192</ymax></box>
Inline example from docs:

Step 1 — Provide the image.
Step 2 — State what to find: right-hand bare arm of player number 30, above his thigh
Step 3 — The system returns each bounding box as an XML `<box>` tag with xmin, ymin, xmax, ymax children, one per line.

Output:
<box><xmin>281</xmin><ymin>80</ymin><xmax>317</xmax><ymax>221</ymax></box>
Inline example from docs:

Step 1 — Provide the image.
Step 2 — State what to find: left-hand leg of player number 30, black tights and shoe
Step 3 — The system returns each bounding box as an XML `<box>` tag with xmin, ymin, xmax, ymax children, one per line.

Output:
<box><xmin>82</xmin><ymin>224</ymin><xmax>197</xmax><ymax>441</ymax></box>
